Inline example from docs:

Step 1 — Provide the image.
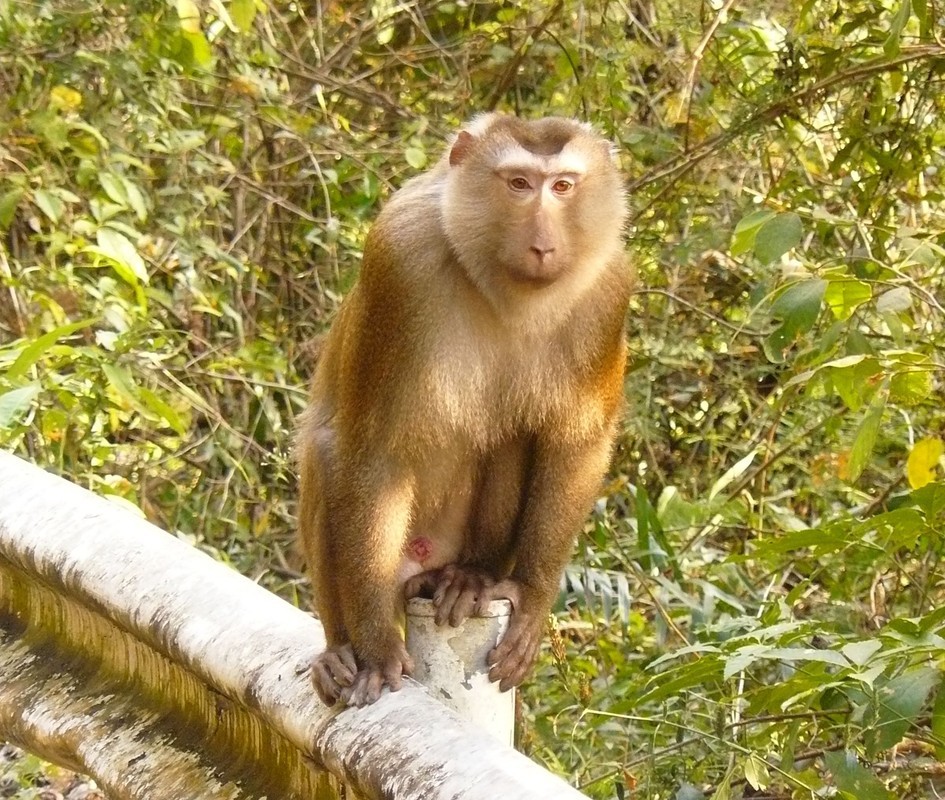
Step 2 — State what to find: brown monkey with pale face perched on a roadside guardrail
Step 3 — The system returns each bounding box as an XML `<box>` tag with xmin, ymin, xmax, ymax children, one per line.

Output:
<box><xmin>295</xmin><ymin>113</ymin><xmax>634</xmax><ymax>706</ymax></box>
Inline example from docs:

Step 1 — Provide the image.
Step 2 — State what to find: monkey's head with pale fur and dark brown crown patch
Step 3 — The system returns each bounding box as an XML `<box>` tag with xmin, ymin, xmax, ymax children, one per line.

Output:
<box><xmin>443</xmin><ymin>114</ymin><xmax>626</xmax><ymax>308</ymax></box>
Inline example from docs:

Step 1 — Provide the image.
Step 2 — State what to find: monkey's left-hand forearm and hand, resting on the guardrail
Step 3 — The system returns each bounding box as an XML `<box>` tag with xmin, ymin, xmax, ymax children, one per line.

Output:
<box><xmin>327</xmin><ymin>467</ymin><xmax>413</xmax><ymax>706</ymax></box>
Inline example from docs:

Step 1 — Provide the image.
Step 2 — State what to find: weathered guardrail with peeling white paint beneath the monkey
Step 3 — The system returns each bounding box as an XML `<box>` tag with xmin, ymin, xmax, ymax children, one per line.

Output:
<box><xmin>0</xmin><ymin>453</ymin><xmax>583</xmax><ymax>800</ymax></box>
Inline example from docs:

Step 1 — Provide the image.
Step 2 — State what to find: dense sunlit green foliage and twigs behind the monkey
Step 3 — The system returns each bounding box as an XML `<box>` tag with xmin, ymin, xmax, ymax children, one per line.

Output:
<box><xmin>0</xmin><ymin>0</ymin><xmax>945</xmax><ymax>800</ymax></box>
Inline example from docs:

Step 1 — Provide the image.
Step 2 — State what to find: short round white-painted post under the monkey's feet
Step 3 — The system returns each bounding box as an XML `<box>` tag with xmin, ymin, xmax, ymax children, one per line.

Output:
<box><xmin>407</xmin><ymin>597</ymin><xmax>515</xmax><ymax>745</ymax></box>
